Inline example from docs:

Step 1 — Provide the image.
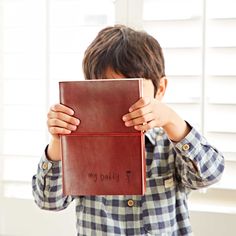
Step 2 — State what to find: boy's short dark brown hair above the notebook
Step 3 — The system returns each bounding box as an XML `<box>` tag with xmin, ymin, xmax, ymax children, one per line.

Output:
<box><xmin>83</xmin><ymin>25</ymin><xmax>165</xmax><ymax>94</ymax></box>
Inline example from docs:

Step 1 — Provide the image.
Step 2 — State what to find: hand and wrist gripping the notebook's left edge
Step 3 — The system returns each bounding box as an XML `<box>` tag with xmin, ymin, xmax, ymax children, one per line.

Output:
<box><xmin>47</xmin><ymin>104</ymin><xmax>80</xmax><ymax>161</ymax></box>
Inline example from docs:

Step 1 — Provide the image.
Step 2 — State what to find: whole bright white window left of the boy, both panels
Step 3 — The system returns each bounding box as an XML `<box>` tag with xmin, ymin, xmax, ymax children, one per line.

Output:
<box><xmin>0</xmin><ymin>0</ymin><xmax>115</xmax><ymax>201</ymax></box>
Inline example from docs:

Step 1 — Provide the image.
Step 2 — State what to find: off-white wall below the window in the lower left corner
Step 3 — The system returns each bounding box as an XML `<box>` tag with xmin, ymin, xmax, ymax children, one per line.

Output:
<box><xmin>0</xmin><ymin>199</ymin><xmax>76</xmax><ymax>236</ymax></box>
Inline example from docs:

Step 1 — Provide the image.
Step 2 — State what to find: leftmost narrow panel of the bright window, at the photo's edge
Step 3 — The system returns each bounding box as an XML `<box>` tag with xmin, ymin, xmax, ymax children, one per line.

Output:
<box><xmin>0</xmin><ymin>0</ymin><xmax>47</xmax><ymax>198</ymax></box>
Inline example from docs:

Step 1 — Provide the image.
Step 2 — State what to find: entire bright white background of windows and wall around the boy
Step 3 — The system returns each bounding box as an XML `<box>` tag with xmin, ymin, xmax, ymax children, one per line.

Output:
<box><xmin>0</xmin><ymin>0</ymin><xmax>236</xmax><ymax>236</ymax></box>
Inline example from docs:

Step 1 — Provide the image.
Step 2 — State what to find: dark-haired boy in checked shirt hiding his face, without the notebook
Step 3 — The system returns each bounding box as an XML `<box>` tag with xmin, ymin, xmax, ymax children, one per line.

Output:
<box><xmin>33</xmin><ymin>25</ymin><xmax>224</xmax><ymax>236</ymax></box>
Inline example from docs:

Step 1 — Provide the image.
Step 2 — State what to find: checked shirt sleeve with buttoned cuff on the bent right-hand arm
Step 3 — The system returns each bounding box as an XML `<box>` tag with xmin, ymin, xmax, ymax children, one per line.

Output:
<box><xmin>174</xmin><ymin>125</ymin><xmax>224</xmax><ymax>189</ymax></box>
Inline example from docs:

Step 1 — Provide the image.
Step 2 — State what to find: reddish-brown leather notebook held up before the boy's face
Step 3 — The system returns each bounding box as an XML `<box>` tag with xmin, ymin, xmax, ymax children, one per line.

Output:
<box><xmin>59</xmin><ymin>79</ymin><xmax>146</xmax><ymax>196</ymax></box>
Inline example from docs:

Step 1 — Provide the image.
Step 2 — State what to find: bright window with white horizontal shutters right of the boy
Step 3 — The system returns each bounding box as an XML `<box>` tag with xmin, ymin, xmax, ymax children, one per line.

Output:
<box><xmin>141</xmin><ymin>0</ymin><xmax>236</xmax><ymax>213</ymax></box>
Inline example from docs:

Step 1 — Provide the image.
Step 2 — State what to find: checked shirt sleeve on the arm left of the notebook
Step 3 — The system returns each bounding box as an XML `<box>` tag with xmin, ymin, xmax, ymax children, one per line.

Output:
<box><xmin>32</xmin><ymin>148</ymin><xmax>73</xmax><ymax>211</ymax></box>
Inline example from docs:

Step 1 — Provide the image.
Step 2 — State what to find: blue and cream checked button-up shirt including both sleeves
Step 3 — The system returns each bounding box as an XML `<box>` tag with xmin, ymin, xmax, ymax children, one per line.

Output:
<box><xmin>32</xmin><ymin>128</ymin><xmax>224</xmax><ymax>236</ymax></box>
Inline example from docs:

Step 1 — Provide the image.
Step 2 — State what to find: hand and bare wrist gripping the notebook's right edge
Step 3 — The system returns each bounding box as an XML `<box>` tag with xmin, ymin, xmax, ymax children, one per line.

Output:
<box><xmin>122</xmin><ymin>97</ymin><xmax>190</xmax><ymax>142</ymax></box>
